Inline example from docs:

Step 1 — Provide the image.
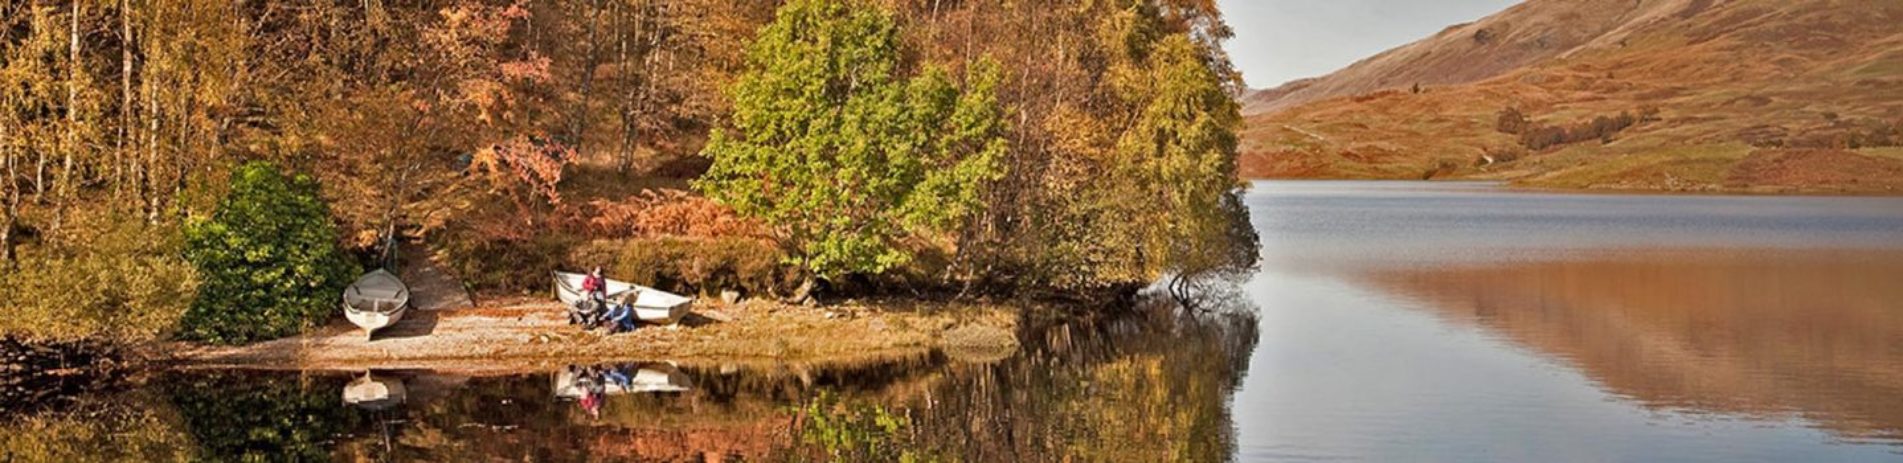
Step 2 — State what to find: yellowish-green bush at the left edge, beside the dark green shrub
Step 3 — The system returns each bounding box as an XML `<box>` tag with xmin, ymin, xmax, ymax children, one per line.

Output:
<box><xmin>0</xmin><ymin>217</ymin><xmax>198</xmax><ymax>341</ymax></box>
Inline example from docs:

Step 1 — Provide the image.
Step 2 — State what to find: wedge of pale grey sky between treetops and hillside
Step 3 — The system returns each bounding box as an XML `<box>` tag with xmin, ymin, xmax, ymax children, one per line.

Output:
<box><xmin>1218</xmin><ymin>0</ymin><xmax>1519</xmax><ymax>88</ymax></box>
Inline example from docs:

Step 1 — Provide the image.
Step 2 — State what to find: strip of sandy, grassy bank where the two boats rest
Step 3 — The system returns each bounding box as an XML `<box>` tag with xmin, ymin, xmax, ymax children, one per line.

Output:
<box><xmin>162</xmin><ymin>301</ymin><xmax>1018</xmax><ymax>370</ymax></box>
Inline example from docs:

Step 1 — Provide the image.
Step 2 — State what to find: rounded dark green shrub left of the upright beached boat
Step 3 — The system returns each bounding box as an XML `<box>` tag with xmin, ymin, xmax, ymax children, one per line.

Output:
<box><xmin>181</xmin><ymin>162</ymin><xmax>356</xmax><ymax>343</ymax></box>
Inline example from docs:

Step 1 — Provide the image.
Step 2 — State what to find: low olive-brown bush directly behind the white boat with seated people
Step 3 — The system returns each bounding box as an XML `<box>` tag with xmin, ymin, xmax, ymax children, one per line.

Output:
<box><xmin>569</xmin><ymin>238</ymin><xmax>801</xmax><ymax>295</ymax></box>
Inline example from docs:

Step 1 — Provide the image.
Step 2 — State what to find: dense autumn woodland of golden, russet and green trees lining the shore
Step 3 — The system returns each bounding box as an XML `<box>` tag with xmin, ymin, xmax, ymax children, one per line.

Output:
<box><xmin>0</xmin><ymin>0</ymin><xmax>1254</xmax><ymax>341</ymax></box>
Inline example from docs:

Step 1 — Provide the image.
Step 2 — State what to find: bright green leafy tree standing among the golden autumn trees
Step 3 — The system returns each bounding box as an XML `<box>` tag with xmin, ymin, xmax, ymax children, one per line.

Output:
<box><xmin>696</xmin><ymin>0</ymin><xmax>1009</xmax><ymax>280</ymax></box>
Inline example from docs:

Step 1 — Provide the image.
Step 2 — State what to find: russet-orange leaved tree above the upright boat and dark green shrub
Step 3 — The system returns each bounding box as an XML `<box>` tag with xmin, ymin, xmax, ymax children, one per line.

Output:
<box><xmin>300</xmin><ymin>2</ymin><xmax>575</xmax><ymax>248</ymax></box>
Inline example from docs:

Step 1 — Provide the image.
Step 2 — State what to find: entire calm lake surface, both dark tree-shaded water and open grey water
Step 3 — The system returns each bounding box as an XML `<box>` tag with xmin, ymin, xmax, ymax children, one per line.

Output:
<box><xmin>0</xmin><ymin>183</ymin><xmax>1903</xmax><ymax>461</ymax></box>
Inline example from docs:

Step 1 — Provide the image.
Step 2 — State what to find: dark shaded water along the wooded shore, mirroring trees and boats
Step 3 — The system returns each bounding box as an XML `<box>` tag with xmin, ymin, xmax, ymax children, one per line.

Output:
<box><xmin>0</xmin><ymin>295</ymin><xmax>1258</xmax><ymax>461</ymax></box>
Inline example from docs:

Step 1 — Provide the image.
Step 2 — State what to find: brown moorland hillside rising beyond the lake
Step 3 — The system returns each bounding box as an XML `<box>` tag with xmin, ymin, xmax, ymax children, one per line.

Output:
<box><xmin>1241</xmin><ymin>0</ymin><xmax>1903</xmax><ymax>192</ymax></box>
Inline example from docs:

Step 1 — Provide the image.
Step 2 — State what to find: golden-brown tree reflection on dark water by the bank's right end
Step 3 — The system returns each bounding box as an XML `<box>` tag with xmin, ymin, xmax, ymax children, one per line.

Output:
<box><xmin>787</xmin><ymin>303</ymin><xmax>1258</xmax><ymax>461</ymax></box>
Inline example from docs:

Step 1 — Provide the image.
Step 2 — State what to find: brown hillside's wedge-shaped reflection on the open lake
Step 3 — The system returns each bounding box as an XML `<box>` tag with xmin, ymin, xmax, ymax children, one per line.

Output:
<box><xmin>1359</xmin><ymin>250</ymin><xmax>1903</xmax><ymax>440</ymax></box>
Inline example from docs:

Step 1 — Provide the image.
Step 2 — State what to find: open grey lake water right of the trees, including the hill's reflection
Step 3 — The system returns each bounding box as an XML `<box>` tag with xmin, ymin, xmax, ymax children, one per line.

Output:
<box><xmin>1237</xmin><ymin>183</ymin><xmax>1903</xmax><ymax>461</ymax></box>
